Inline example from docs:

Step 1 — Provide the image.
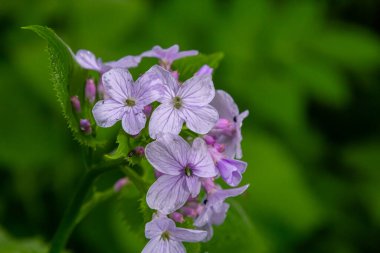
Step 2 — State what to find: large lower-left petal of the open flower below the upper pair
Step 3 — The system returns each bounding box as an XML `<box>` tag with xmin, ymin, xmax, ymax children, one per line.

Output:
<box><xmin>146</xmin><ymin>175</ymin><xmax>190</xmax><ymax>214</ymax></box>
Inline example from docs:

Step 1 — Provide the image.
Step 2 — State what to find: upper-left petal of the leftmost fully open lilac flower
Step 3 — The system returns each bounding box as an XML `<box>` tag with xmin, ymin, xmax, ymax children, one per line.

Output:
<box><xmin>102</xmin><ymin>69</ymin><xmax>133</xmax><ymax>103</ymax></box>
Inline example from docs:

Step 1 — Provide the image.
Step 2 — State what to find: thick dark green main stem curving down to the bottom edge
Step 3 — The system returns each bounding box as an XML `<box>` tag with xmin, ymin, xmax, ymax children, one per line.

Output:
<box><xmin>49</xmin><ymin>161</ymin><xmax>123</xmax><ymax>253</ymax></box>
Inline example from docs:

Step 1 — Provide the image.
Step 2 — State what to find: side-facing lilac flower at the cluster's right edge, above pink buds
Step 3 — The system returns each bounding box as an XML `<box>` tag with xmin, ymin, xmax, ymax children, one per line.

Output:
<box><xmin>210</xmin><ymin>90</ymin><xmax>248</xmax><ymax>159</ymax></box>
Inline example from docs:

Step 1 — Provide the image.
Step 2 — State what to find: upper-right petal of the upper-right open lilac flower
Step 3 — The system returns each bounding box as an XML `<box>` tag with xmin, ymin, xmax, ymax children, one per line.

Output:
<box><xmin>177</xmin><ymin>75</ymin><xmax>215</xmax><ymax>106</ymax></box>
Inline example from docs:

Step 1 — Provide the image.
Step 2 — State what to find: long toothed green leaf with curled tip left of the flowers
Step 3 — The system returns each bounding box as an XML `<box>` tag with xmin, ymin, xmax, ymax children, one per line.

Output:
<box><xmin>23</xmin><ymin>25</ymin><xmax>105</xmax><ymax>147</ymax></box>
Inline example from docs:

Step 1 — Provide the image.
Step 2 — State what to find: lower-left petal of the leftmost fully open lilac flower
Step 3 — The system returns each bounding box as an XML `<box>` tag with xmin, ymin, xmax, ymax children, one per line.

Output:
<box><xmin>92</xmin><ymin>99</ymin><xmax>125</xmax><ymax>127</ymax></box>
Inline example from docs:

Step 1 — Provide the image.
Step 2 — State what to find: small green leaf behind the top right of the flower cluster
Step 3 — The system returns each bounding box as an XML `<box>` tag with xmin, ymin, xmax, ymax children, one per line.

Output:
<box><xmin>173</xmin><ymin>53</ymin><xmax>224</xmax><ymax>80</ymax></box>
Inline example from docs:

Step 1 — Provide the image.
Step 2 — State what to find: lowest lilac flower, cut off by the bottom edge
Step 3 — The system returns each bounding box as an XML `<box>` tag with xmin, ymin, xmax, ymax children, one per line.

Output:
<box><xmin>142</xmin><ymin>216</ymin><xmax>207</xmax><ymax>253</ymax></box>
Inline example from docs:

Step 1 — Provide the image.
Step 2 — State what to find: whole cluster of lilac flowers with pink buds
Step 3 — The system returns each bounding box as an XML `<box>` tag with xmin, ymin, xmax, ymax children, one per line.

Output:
<box><xmin>71</xmin><ymin>45</ymin><xmax>248</xmax><ymax>253</ymax></box>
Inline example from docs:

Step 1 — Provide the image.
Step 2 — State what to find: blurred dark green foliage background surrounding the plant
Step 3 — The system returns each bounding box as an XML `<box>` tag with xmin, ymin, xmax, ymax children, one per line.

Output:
<box><xmin>0</xmin><ymin>0</ymin><xmax>380</xmax><ymax>253</ymax></box>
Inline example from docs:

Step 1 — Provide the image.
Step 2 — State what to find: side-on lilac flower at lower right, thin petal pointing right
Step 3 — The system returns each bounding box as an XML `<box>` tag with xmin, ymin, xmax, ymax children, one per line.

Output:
<box><xmin>194</xmin><ymin>185</ymin><xmax>249</xmax><ymax>239</ymax></box>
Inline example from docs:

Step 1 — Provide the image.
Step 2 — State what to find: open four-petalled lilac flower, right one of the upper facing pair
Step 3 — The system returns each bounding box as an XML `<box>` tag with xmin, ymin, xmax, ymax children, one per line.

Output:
<box><xmin>149</xmin><ymin>68</ymin><xmax>218</xmax><ymax>138</ymax></box>
